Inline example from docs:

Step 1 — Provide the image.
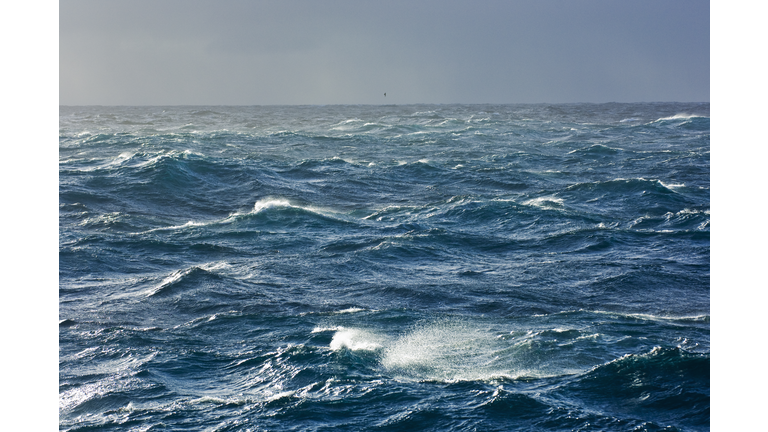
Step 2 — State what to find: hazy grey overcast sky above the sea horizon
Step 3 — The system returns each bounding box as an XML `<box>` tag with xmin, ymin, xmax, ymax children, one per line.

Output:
<box><xmin>59</xmin><ymin>0</ymin><xmax>710</xmax><ymax>105</ymax></box>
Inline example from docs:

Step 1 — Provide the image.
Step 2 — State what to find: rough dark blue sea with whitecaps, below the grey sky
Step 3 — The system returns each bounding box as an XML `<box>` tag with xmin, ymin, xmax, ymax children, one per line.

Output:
<box><xmin>59</xmin><ymin>103</ymin><xmax>710</xmax><ymax>431</ymax></box>
